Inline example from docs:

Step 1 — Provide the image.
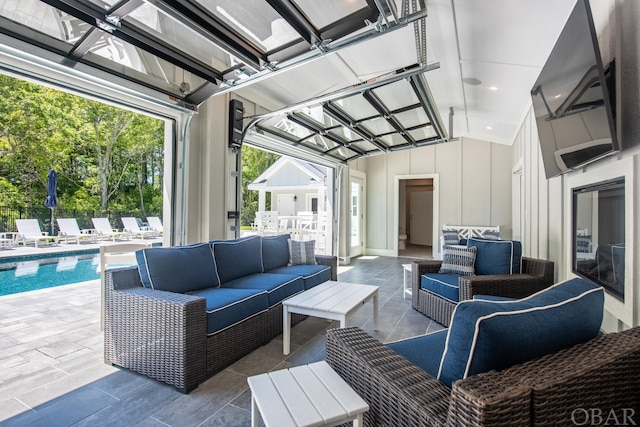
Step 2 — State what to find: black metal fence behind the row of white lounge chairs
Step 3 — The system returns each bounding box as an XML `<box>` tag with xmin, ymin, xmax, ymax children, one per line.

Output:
<box><xmin>0</xmin><ymin>206</ymin><xmax>160</xmax><ymax>233</ymax></box>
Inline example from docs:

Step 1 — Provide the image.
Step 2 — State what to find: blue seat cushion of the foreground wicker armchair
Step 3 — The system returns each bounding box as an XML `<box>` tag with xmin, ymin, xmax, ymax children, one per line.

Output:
<box><xmin>387</xmin><ymin>329</ymin><xmax>447</xmax><ymax>378</ymax></box>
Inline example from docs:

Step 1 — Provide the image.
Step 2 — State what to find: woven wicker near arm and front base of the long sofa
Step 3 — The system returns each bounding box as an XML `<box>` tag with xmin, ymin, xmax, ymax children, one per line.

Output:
<box><xmin>104</xmin><ymin>267</ymin><xmax>306</xmax><ymax>393</ymax></box>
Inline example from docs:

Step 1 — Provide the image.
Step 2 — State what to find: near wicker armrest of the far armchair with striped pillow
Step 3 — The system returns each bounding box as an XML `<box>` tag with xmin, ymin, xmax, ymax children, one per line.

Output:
<box><xmin>458</xmin><ymin>274</ymin><xmax>552</xmax><ymax>301</ymax></box>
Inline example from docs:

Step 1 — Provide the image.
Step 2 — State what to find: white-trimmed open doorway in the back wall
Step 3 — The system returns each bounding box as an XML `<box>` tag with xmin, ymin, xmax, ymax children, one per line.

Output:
<box><xmin>396</xmin><ymin>175</ymin><xmax>438</xmax><ymax>258</ymax></box>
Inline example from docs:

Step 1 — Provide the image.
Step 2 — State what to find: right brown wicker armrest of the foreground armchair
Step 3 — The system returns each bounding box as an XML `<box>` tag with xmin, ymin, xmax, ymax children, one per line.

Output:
<box><xmin>450</xmin><ymin>327</ymin><xmax>640</xmax><ymax>426</ymax></box>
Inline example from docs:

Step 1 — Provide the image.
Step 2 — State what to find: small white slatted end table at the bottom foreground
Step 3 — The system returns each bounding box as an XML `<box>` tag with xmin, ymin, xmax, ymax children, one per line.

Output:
<box><xmin>247</xmin><ymin>361</ymin><xmax>369</xmax><ymax>427</ymax></box>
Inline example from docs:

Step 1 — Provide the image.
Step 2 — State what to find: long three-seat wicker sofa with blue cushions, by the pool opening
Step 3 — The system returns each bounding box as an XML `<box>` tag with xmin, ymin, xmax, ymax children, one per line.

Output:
<box><xmin>104</xmin><ymin>235</ymin><xmax>337</xmax><ymax>393</ymax></box>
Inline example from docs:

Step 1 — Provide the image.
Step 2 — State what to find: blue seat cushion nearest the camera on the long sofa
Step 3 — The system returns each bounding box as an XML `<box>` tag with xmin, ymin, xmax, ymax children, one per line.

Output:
<box><xmin>189</xmin><ymin>288</ymin><xmax>269</xmax><ymax>335</ymax></box>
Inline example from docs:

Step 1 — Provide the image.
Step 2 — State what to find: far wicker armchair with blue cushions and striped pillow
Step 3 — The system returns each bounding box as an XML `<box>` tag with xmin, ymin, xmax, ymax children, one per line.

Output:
<box><xmin>411</xmin><ymin>238</ymin><xmax>554</xmax><ymax>326</ymax></box>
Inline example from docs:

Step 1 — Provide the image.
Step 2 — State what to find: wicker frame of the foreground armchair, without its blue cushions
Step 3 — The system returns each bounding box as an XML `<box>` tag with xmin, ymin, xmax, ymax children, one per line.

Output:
<box><xmin>327</xmin><ymin>280</ymin><xmax>640</xmax><ymax>427</ymax></box>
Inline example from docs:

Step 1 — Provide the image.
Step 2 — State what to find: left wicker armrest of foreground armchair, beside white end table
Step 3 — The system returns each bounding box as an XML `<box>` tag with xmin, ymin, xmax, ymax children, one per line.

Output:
<box><xmin>327</xmin><ymin>328</ymin><xmax>451</xmax><ymax>427</ymax></box>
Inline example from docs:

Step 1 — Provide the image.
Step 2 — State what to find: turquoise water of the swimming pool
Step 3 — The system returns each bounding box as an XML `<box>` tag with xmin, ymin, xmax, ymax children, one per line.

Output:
<box><xmin>0</xmin><ymin>254</ymin><xmax>100</xmax><ymax>296</ymax></box>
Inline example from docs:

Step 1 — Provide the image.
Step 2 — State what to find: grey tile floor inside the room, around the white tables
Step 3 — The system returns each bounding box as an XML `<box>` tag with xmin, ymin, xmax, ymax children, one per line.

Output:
<box><xmin>0</xmin><ymin>256</ymin><xmax>442</xmax><ymax>427</ymax></box>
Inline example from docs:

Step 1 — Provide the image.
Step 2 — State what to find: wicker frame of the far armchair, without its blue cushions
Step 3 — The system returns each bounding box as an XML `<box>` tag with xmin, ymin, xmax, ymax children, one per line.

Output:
<box><xmin>411</xmin><ymin>257</ymin><xmax>554</xmax><ymax>326</ymax></box>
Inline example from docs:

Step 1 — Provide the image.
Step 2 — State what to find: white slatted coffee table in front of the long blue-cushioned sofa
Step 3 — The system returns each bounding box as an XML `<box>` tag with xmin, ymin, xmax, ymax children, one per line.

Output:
<box><xmin>282</xmin><ymin>280</ymin><xmax>378</xmax><ymax>354</ymax></box>
